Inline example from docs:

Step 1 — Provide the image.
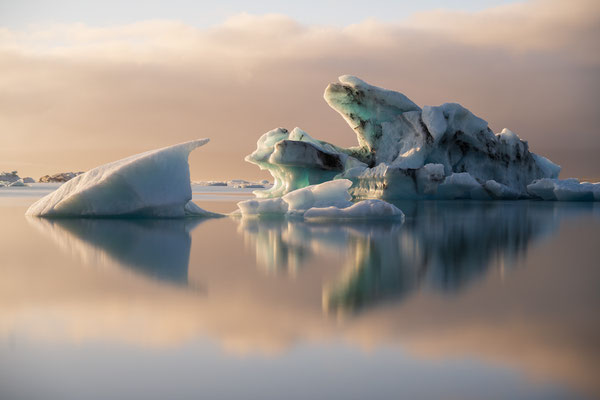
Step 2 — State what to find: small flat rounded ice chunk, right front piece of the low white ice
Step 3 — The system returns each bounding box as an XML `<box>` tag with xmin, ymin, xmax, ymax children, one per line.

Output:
<box><xmin>304</xmin><ymin>199</ymin><xmax>404</xmax><ymax>221</ymax></box>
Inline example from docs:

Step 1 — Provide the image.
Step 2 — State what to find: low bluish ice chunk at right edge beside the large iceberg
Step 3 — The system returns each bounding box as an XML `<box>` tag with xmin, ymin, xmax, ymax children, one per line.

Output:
<box><xmin>527</xmin><ymin>178</ymin><xmax>600</xmax><ymax>201</ymax></box>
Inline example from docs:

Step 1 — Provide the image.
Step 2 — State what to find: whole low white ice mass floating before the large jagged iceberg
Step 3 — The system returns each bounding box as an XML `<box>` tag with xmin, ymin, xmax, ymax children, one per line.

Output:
<box><xmin>238</xmin><ymin>179</ymin><xmax>404</xmax><ymax>220</ymax></box>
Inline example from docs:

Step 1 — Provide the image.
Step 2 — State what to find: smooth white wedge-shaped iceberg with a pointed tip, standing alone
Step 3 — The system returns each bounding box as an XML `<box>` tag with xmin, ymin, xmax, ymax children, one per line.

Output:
<box><xmin>26</xmin><ymin>139</ymin><xmax>223</xmax><ymax>217</ymax></box>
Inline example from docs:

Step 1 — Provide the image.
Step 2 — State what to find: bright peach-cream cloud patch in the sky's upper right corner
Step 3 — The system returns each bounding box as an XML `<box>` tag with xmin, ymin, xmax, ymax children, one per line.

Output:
<box><xmin>408</xmin><ymin>0</ymin><xmax>600</xmax><ymax>61</ymax></box>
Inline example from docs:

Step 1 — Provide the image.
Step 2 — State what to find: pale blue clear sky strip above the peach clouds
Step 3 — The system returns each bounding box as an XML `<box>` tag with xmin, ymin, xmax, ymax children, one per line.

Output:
<box><xmin>0</xmin><ymin>0</ymin><xmax>515</xmax><ymax>29</ymax></box>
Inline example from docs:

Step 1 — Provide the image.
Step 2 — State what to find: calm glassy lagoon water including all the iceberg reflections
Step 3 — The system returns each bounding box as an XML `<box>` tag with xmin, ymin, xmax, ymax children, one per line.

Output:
<box><xmin>0</xmin><ymin>188</ymin><xmax>600</xmax><ymax>400</ymax></box>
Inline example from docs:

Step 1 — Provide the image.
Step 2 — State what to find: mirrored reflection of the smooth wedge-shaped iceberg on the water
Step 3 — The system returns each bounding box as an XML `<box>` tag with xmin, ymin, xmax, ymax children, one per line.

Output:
<box><xmin>28</xmin><ymin>218</ymin><xmax>203</xmax><ymax>284</ymax></box>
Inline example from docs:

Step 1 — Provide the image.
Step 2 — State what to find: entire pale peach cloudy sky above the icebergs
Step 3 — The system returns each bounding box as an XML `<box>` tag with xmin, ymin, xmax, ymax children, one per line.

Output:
<box><xmin>0</xmin><ymin>0</ymin><xmax>600</xmax><ymax>180</ymax></box>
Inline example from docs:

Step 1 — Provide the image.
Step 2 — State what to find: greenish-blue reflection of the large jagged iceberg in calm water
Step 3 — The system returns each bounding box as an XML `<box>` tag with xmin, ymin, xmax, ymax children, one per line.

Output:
<box><xmin>238</xmin><ymin>202</ymin><xmax>593</xmax><ymax>312</ymax></box>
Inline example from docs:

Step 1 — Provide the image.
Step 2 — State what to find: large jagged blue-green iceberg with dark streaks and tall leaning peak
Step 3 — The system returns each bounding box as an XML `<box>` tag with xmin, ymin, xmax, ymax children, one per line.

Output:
<box><xmin>246</xmin><ymin>75</ymin><xmax>598</xmax><ymax>200</ymax></box>
